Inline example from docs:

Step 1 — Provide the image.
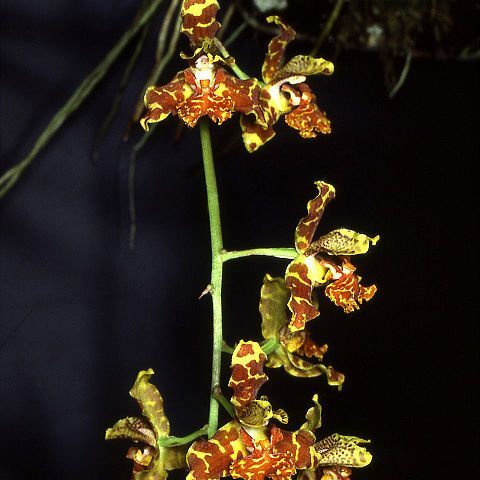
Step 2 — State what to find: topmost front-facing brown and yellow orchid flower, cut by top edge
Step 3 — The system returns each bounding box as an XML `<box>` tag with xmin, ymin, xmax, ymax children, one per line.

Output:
<box><xmin>140</xmin><ymin>0</ymin><xmax>264</xmax><ymax>131</ymax></box>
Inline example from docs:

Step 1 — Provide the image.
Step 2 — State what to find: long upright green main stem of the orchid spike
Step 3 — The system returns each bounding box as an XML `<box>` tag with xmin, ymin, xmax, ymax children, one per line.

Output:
<box><xmin>200</xmin><ymin>118</ymin><xmax>223</xmax><ymax>438</ymax></box>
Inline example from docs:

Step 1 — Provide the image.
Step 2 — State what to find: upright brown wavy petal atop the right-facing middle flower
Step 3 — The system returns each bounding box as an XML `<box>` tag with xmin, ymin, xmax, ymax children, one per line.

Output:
<box><xmin>295</xmin><ymin>181</ymin><xmax>335</xmax><ymax>253</ymax></box>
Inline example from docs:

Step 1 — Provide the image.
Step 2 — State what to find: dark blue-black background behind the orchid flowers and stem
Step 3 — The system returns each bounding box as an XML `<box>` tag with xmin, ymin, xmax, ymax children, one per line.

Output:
<box><xmin>0</xmin><ymin>0</ymin><xmax>479</xmax><ymax>480</ymax></box>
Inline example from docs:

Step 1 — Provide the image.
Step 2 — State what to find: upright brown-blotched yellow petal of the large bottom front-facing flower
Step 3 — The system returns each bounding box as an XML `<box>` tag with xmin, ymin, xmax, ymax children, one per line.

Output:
<box><xmin>228</xmin><ymin>340</ymin><xmax>268</xmax><ymax>407</ymax></box>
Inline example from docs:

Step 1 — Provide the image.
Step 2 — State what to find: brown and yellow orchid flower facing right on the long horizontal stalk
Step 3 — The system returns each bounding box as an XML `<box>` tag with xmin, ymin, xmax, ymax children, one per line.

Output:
<box><xmin>285</xmin><ymin>181</ymin><xmax>380</xmax><ymax>332</ymax></box>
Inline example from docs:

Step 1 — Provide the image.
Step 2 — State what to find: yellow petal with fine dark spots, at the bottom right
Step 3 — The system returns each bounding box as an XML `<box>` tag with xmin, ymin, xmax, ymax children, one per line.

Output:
<box><xmin>314</xmin><ymin>433</ymin><xmax>372</xmax><ymax>467</ymax></box>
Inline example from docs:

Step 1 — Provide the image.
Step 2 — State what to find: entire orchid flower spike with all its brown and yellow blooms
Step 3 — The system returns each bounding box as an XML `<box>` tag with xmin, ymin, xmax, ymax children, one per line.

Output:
<box><xmin>106</xmin><ymin>0</ymin><xmax>379</xmax><ymax>480</ymax></box>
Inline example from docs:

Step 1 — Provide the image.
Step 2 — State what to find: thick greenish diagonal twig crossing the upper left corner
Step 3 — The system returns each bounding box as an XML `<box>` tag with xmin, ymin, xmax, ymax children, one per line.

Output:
<box><xmin>0</xmin><ymin>0</ymin><xmax>163</xmax><ymax>198</ymax></box>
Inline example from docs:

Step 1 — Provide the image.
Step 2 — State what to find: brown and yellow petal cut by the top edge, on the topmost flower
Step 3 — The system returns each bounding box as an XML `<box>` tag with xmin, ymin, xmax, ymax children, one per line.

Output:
<box><xmin>181</xmin><ymin>0</ymin><xmax>220</xmax><ymax>47</ymax></box>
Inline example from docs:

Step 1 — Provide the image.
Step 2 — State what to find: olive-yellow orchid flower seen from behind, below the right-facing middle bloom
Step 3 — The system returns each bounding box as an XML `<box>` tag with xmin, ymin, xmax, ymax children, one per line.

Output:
<box><xmin>259</xmin><ymin>275</ymin><xmax>345</xmax><ymax>389</ymax></box>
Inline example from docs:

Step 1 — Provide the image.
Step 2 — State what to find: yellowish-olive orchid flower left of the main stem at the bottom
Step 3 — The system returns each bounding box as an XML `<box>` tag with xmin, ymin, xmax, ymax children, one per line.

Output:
<box><xmin>105</xmin><ymin>368</ymin><xmax>186</xmax><ymax>480</ymax></box>
